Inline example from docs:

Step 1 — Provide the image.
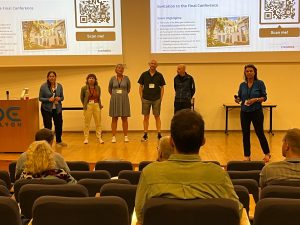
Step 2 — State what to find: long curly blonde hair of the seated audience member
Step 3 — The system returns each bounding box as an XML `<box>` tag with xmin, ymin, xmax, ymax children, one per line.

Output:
<box><xmin>25</xmin><ymin>141</ymin><xmax>56</xmax><ymax>174</ymax></box>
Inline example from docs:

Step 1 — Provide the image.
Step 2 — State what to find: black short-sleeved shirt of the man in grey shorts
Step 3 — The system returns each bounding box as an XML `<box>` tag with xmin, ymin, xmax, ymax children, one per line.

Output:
<box><xmin>138</xmin><ymin>70</ymin><xmax>166</xmax><ymax>101</ymax></box>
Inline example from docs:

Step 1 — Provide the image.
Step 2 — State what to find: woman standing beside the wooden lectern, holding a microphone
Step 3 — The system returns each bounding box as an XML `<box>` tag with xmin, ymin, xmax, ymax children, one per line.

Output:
<box><xmin>39</xmin><ymin>71</ymin><xmax>67</xmax><ymax>147</ymax></box>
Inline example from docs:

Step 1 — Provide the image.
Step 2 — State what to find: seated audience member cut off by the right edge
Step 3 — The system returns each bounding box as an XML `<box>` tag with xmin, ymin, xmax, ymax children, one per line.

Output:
<box><xmin>259</xmin><ymin>128</ymin><xmax>300</xmax><ymax>188</ymax></box>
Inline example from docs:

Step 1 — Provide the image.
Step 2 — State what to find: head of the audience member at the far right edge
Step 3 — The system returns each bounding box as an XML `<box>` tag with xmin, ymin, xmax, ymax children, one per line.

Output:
<box><xmin>282</xmin><ymin>128</ymin><xmax>300</xmax><ymax>158</ymax></box>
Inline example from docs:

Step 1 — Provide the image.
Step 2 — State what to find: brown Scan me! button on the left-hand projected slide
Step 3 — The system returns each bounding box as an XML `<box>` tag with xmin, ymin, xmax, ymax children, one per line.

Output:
<box><xmin>76</xmin><ymin>31</ymin><xmax>116</xmax><ymax>41</ymax></box>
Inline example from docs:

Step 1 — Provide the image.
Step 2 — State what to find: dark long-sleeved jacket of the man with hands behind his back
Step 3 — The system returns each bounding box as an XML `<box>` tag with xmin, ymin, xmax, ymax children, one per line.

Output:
<box><xmin>174</xmin><ymin>73</ymin><xmax>196</xmax><ymax>102</ymax></box>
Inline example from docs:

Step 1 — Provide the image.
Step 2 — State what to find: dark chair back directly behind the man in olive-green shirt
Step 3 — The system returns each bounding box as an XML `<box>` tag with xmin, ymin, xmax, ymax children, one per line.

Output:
<box><xmin>143</xmin><ymin>198</ymin><xmax>240</xmax><ymax>225</ymax></box>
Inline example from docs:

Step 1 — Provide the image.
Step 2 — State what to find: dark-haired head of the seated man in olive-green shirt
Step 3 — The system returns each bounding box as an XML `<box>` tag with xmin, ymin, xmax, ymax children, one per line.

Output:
<box><xmin>171</xmin><ymin>109</ymin><xmax>205</xmax><ymax>154</ymax></box>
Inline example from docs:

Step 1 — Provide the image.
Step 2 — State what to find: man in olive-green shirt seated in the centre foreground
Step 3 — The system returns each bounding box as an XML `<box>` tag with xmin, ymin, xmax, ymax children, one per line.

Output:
<box><xmin>135</xmin><ymin>109</ymin><xmax>243</xmax><ymax>224</ymax></box>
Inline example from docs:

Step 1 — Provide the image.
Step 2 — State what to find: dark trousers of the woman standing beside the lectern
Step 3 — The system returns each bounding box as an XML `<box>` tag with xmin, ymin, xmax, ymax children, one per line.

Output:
<box><xmin>41</xmin><ymin>108</ymin><xmax>63</xmax><ymax>143</ymax></box>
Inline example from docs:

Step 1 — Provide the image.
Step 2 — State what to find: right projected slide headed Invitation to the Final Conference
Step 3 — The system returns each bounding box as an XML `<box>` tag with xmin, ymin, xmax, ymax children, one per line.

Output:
<box><xmin>150</xmin><ymin>0</ymin><xmax>300</xmax><ymax>54</ymax></box>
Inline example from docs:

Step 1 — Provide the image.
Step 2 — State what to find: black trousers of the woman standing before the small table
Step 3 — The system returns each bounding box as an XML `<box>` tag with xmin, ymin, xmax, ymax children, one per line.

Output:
<box><xmin>241</xmin><ymin>109</ymin><xmax>270</xmax><ymax>156</ymax></box>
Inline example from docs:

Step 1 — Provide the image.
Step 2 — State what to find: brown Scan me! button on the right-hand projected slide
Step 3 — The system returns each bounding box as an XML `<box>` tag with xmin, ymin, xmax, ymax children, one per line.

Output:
<box><xmin>259</xmin><ymin>26</ymin><xmax>299</xmax><ymax>38</ymax></box>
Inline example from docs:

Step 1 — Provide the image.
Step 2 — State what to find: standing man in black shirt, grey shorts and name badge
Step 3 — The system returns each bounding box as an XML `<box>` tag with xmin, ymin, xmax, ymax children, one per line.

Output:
<box><xmin>138</xmin><ymin>59</ymin><xmax>166</xmax><ymax>141</ymax></box>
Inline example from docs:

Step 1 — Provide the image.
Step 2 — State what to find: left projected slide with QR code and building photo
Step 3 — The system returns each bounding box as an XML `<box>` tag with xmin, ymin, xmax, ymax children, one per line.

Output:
<box><xmin>0</xmin><ymin>0</ymin><xmax>122</xmax><ymax>56</ymax></box>
